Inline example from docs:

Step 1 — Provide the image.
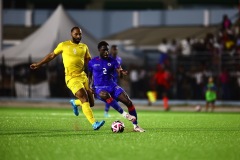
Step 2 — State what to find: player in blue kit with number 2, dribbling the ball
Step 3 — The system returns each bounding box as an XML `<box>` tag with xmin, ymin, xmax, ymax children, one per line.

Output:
<box><xmin>88</xmin><ymin>41</ymin><xmax>145</xmax><ymax>132</ymax></box>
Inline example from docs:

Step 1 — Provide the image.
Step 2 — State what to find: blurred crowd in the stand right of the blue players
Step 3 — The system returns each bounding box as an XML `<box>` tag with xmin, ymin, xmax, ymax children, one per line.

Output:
<box><xmin>127</xmin><ymin>15</ymin><xmax>240</xmax><ymax>100</ymax></box>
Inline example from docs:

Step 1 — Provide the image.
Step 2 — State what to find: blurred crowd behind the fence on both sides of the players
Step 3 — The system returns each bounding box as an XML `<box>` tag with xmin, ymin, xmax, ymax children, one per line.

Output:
<box><xmin>0</xmin><ymin>15</ymin><xmax>240</xmax><ymax>100</ymax></box>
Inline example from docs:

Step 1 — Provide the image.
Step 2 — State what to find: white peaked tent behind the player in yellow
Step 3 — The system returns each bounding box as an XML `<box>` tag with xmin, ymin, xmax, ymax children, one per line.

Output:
<box><xmin>0</xmin><ymin>5</ymin><xmax>140</xmax><ymax>67</ymax></box>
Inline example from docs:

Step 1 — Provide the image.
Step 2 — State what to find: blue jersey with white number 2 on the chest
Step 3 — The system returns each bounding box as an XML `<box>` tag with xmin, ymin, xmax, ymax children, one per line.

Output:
<box><xmin>88</xmin><ymin>56</ymin><xmax>120</xmax><ymax>87</ymax></box>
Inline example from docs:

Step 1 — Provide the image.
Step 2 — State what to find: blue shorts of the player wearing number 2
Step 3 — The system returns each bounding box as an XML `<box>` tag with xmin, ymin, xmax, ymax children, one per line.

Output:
<box><xmin>94</xmin><ymin>85</ymin><xmax>124</xmax><ymax>102</ymax></box>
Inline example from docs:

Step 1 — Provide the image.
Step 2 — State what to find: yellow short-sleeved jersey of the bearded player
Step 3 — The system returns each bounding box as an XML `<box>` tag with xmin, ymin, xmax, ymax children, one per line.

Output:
<box><xmin>53</xmin><ymin>40</ymin><xmax>91</xmax><ymax>82</ymax></box>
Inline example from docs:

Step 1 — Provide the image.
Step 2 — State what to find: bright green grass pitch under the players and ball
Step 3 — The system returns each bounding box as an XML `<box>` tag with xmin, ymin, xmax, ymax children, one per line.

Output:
<box><xmin>0</xmin><ymin>107</ymin><xmax>240</xmax><ymax>160</ymax></box>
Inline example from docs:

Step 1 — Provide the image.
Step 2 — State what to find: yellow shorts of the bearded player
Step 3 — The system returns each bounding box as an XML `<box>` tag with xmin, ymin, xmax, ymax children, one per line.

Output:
<box><xmin>66</xmin><ymin>75</ymin><xmax>89</xmax><ymax>95</ymax></box>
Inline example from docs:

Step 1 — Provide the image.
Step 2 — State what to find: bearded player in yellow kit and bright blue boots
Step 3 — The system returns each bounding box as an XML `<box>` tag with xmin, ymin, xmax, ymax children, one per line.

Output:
<box><xmin>30</xmin><ymin>27</ymin><xmax>105</xmax><ymax>130</ymax></box>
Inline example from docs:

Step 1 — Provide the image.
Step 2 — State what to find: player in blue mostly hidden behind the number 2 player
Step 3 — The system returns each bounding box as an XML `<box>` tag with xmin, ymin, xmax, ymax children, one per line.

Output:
<box><xmin>104</xmin><ymin>45</ymin><xmax>122</xmax><ymax>117</ymax></box>
